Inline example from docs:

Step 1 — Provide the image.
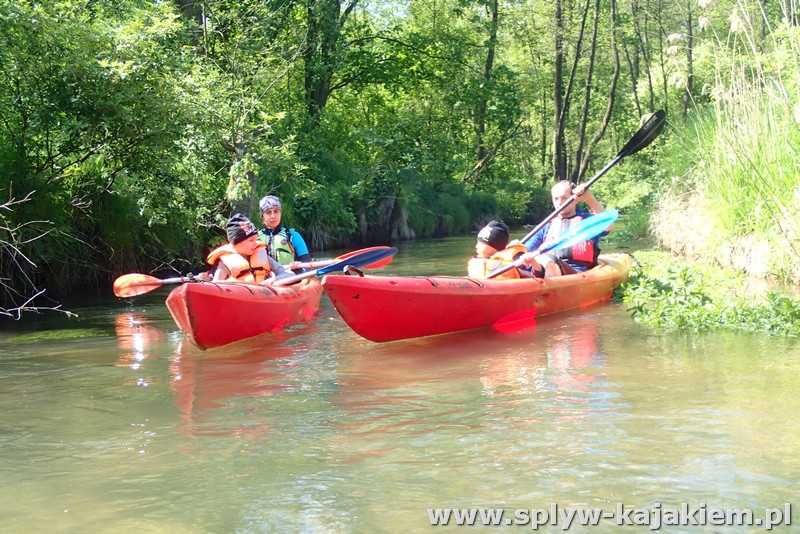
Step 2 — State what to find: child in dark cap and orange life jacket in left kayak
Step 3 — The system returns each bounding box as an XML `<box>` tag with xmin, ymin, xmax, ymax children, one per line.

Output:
<box><xmin>208</xmin><ymin>213</ymin><xmax>292</xmax><ymax>284</ymax></box>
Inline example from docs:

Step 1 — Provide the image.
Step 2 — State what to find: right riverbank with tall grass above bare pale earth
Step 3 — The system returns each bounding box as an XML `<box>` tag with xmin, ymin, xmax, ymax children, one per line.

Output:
<box><xmin>650</xmin><ymin>21</ymin><xmax>800</xmax><ymax>283</ymax></box>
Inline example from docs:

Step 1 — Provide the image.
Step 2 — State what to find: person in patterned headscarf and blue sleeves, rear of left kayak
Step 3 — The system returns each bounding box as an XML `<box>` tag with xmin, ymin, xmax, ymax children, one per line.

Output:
<box><xmin>258</xmin><ymin>195</ymin><xmax>312</xmax><ymax>271</ymax></box>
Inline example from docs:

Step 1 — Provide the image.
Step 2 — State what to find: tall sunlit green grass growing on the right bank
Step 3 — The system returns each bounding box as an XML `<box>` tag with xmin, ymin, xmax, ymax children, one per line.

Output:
<box><xmin>656</xmin><ymin>14</ymin><xmax>800</xmax><ymax>277</ymax></box>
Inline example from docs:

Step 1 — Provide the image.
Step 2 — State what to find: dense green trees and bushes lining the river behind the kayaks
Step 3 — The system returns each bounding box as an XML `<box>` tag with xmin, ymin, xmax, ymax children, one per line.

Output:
<box><xmin>0</xmin><ymin>0</ymin><xmax>798</xmax><ymax>310</ymax></box>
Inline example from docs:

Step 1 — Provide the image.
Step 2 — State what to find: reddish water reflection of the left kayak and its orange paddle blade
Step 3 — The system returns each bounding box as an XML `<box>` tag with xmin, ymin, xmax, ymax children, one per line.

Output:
<box><xmin>114</xmin><ymin>312</ymin><xmax>315</xmax><ymax>438</ymax></box>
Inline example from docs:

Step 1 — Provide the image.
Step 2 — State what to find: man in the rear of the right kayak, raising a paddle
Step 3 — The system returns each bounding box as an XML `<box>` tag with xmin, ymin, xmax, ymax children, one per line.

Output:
<box><xmin>520</xmin><ymin>180</ymin><xmax>610</xmax><ymax>278</ymax></box>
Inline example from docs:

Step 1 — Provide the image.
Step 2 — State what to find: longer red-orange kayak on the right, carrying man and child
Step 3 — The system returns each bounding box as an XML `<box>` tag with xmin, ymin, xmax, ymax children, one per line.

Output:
<box><xmin>322</xmin><ymin>254</ymin><xmax>632</xmax><ymax>341</ymax></box>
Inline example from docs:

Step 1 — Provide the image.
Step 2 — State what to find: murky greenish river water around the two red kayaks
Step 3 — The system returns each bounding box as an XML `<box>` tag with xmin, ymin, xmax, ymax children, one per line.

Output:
<box><xmin>0</xmin><ymin>238</ymin><xmax>800</xmax><ymax>533</ymax></box>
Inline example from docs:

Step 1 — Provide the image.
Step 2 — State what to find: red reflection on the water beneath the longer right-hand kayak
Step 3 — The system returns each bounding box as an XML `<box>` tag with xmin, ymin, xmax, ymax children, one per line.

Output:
<box><xmin>339</xmin><ymin>314</ymin><xmax>606</xmax><ymax>404</ymax></box>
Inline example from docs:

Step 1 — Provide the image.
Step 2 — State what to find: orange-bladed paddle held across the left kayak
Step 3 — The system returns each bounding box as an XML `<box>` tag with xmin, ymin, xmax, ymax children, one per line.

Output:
<box><xmin>114</xmin><ymin>246</ymin><xmax>397</xmax><ymax>298</ymax></box>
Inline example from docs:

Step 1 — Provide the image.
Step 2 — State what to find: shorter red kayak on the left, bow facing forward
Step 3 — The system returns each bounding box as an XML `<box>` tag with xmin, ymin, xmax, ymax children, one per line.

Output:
<box><xmin>167</xmin><ymin>278</ymin><xmax>322</xmax><ymax>349</ymax></box>
